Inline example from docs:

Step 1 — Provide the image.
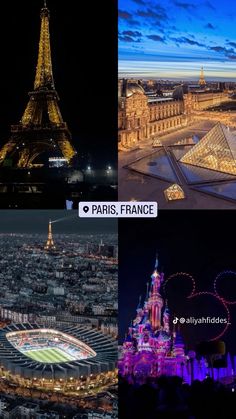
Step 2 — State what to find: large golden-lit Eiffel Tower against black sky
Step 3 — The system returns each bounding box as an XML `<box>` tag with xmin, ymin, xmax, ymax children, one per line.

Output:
<box><xmin>0</xmin><ymin>0</ymin><xmax>76</xmax><ymax>168</ymax></box>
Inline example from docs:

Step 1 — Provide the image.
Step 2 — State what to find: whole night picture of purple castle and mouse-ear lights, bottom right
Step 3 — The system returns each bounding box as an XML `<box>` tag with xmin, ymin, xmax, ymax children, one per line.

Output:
<box><xmin>118</xmin><ymin>211</ymin><xmax>236</xmax><ymax>419</ymax></box>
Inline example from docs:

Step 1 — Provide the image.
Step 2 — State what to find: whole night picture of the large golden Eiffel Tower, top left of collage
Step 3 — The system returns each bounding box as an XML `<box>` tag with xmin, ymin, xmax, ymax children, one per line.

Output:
<box><xmin>0</xmin><ymin>0</ymin><xmax>117</xmax><ymax>209</ymax></box>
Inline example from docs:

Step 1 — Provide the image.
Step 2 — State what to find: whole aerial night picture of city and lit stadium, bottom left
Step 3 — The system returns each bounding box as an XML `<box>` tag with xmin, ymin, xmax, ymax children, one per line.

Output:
<box><xmin>0</xmin><ymin>210</ymin><xmax>118</xmax><ymax>419</ymax></box>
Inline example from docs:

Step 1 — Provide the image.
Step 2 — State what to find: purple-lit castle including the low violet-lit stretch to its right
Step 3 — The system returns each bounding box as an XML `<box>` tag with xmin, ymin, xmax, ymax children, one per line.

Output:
<box><xmin>118</xmin><ymin>259</ymin><xmax>236</xmax><ymax>384</ymax></box>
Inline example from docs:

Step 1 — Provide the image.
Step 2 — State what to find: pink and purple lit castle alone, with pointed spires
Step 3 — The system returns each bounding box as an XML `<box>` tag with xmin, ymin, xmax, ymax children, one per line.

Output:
<box><xmin>119</xmin><ymin>259</ymin><xmax>189</xmax><ymax>379</ymax></box>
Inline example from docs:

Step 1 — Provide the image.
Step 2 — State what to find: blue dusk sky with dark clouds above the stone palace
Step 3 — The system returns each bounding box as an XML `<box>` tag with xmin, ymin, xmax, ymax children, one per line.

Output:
<box><xmin>119</xmin><ymin>0</ymin><xmax>236</xmax><ymax>81</ymax></box>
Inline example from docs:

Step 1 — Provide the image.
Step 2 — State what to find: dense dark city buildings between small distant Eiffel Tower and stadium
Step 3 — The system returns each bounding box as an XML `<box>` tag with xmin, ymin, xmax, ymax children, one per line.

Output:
<box><xmin>0</xmin><ymin>231</ymin><xmax>117</xmax><ymax>326</ymax></box>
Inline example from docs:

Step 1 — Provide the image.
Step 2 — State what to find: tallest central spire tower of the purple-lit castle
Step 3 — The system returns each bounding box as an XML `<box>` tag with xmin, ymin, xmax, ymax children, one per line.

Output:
<box><xmin>148</xmin><ymin>257</ymin><xmax>163</xmax><ymax>331</ymax></box>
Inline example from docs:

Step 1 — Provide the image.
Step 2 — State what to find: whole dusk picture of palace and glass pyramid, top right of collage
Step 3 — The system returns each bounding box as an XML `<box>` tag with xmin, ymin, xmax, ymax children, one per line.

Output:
<box><xmin>118</xmin><ymin>0</ymin><xmax>236</xmax><ymax>209</ymax></box>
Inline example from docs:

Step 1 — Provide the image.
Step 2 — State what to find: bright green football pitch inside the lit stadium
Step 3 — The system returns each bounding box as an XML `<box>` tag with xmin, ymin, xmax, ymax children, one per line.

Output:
<box><xmin>24</xmin><ymin>348</ymin><xmax>74</xmax><ymax>364</ymax></box>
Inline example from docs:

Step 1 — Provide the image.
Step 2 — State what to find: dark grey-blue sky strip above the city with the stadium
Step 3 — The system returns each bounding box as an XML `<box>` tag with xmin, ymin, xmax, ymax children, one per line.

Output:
<box><xmin>0</xmin><ymin>210</ymin><xmax>117</xmax><ymax>235</ymax></box>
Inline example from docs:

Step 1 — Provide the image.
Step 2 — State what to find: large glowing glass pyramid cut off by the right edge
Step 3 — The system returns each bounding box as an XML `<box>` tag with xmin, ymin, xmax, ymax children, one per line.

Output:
<box><xmin>180</xmin><ymin>123</ymin><xmax>236</xmax><ymax>175</ymax></box>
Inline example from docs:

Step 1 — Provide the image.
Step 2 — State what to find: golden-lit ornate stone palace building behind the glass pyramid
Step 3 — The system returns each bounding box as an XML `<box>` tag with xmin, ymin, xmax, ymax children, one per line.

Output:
<box><xmin>118</xmin><ymin>80</ymin><xmax>228</xmax><ymax>149</ymax></box>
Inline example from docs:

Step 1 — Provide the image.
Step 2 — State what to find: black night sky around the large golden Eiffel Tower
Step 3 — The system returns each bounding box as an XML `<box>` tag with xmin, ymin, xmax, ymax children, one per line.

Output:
<box><xmin>0</xmin><ymin>0</ymin><xmax>117</xmax><ymax>169</ymax></box>
